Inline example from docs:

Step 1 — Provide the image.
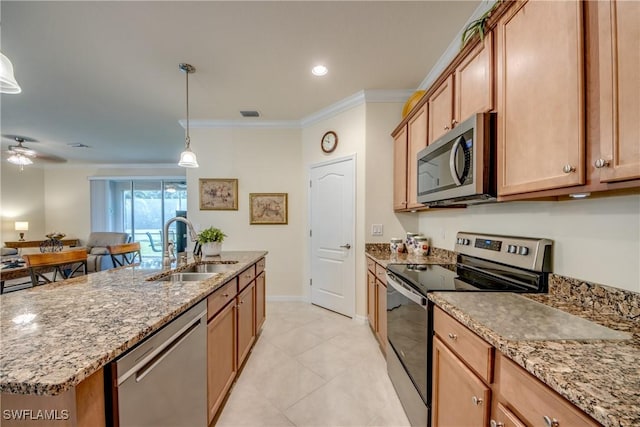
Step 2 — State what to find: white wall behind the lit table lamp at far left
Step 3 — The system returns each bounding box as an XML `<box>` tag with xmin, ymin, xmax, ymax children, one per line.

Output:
<box><xmin>0</xmin><ymin>162</ymin><xmax>47</xmax><ymax>242</ymax></box>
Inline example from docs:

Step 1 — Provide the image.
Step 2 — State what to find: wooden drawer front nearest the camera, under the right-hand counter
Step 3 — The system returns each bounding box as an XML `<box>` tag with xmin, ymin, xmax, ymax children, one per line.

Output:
<box><xmin>496</xmin><ymin>353</ymin><xmax>599</xmax><ymax>426</ymax></box>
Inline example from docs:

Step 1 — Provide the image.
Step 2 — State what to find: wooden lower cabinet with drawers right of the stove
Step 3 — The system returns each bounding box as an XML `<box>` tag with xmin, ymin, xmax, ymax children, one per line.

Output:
<box><xmin>431</xmin><ymin>307</ymin><xmax>599</xmax><ymax>427</ymax></box>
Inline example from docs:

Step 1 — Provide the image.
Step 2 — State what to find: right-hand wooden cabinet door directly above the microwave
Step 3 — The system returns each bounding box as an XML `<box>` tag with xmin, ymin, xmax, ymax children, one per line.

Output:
<box><xmin>453</xmin><ymin>32</ymin><xmax>493</xmax><ymax>125</ymax></box>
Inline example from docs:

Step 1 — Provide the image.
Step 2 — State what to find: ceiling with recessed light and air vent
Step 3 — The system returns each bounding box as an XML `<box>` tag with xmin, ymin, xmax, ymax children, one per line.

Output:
<box><xmin>0</xmin><ymin>0</ymin><xmax>480</xmax><ymax>164</ymax></box>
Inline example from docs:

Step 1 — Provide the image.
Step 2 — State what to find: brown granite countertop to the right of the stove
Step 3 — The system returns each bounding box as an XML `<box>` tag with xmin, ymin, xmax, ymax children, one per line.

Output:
<box><xmin>429</xmin><ymin>292</ymin><xmax>640</xmax><ymax>427</ymax></box>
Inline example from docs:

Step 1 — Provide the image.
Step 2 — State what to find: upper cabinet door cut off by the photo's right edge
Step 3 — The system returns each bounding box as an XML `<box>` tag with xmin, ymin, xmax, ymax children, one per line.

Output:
<box><xmin>593</xmin><ymin>0</ymin><xmax>640</xmax><ymax>182</ymax></box>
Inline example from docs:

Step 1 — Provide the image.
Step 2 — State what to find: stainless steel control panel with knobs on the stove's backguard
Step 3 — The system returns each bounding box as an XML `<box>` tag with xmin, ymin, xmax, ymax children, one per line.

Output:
<box><xmin>455</xmin><ymin>231</ymin><xmax>553</xmax><ymax>271</ymax></box>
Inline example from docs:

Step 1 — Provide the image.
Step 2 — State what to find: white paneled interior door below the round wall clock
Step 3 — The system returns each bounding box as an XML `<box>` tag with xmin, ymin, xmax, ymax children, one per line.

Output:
<box><xmin>309</xmin><ymin>157</ymin><xmax>355</xmax><ymax>317</ymax></box>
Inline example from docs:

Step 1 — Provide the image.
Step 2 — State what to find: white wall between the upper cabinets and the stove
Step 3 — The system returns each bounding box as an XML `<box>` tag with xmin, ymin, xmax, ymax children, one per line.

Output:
<box><xmin>420</xmin><ymin>195</ymin><xmax>640</xmax><ymax>292</ymax></box>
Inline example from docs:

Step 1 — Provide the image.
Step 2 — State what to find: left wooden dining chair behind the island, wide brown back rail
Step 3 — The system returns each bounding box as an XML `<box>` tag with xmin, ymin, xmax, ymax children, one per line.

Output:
<box><xmin>22</xmin><ymin>249</ymin><xmax>87</xmax><ymax>286</ymax></box>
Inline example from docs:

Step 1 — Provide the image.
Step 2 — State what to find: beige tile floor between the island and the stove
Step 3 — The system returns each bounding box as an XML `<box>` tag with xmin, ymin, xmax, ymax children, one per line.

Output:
<box><xmin>216</xmin><ymin>302</ymin><xmax>409</xmax><ymax>427</ymax></box>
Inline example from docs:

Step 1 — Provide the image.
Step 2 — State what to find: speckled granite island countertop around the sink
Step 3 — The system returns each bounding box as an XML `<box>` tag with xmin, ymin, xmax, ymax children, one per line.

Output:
<box><xmin>0</xmin><ymin>251</ymin><xmax>267</xmax><ymax>395</ymax></box>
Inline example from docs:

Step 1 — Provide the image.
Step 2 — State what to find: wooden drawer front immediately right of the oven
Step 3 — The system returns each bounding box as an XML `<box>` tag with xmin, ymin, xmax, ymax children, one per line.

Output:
<box><xmin>433</xmin><ymin>307</ymin><xmax>494</xmax><ymax>384</ymax></box>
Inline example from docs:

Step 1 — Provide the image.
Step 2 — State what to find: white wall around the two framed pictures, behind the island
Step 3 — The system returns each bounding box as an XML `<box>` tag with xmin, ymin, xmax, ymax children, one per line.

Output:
<box><xmin>187</xmin><ymin>129</ymin><xmax>306</xmax><ymax>298</ymax></box>
